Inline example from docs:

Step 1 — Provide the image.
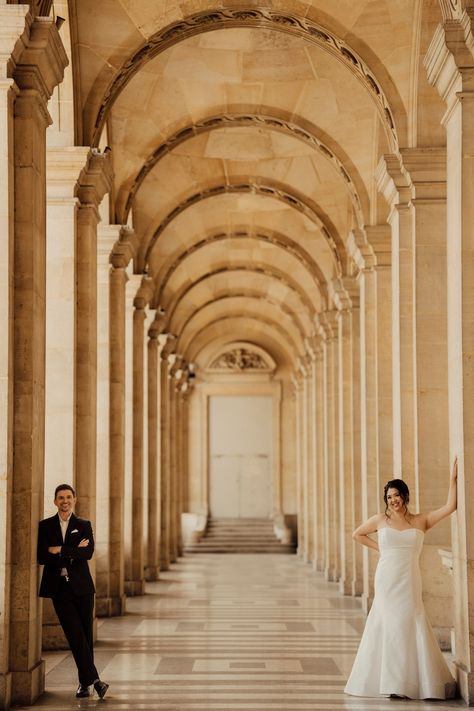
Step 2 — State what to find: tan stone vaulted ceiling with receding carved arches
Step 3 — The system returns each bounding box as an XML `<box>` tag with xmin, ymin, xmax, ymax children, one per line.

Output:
<box><xmin>72</xmin><ymin>0</ymin><xmax>444</xmax><ymax>366</ymax></box>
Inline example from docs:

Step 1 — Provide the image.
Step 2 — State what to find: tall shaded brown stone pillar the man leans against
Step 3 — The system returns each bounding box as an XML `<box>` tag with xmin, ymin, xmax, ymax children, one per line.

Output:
<box><xmin>8</xmin><ymin>7</ymin><xmax>67</xmax><ymax>704</ymax></box>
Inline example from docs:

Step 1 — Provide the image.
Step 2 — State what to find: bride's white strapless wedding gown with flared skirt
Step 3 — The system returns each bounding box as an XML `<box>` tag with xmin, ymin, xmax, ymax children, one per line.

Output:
<box><xmin>345</xmin><ymin>528</ymin><xmax>454</xmax><ymax>699</ymax></box>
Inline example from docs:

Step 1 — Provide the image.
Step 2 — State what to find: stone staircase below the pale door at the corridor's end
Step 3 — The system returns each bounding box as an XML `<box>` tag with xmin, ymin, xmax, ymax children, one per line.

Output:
<box><xmin>184</xmin><ymin>518</ymin><xmax>296</xmax><ymax>553</ymax></box>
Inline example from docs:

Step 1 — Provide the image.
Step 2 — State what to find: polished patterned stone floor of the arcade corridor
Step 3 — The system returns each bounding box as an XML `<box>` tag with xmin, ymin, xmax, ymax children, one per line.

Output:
<box><xmin>20</xmin><ymin>554</ymin><xmax>463</xmax><ymax>711</ymax></box>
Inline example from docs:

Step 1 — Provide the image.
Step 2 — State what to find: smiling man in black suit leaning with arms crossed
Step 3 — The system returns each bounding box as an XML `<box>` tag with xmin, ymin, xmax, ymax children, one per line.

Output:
<box><xmin>38</xmin><ymin>484</ymin><xmax>109</xmax><ymax>699</ymax></box>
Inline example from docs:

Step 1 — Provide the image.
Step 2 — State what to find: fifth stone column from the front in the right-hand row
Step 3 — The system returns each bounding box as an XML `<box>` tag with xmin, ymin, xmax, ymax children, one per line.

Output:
<box><xmin>319</xmin><ymin>311</ymin><xmax>340</xmax><ymax>582</ymax></box>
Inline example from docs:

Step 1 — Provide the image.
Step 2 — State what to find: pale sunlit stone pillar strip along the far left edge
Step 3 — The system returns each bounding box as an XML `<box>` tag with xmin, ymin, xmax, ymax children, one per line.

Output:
<box><xmin>0</xmin><ymin>5</ymin><xmax>31</xmax><ymax>708</ymax></box>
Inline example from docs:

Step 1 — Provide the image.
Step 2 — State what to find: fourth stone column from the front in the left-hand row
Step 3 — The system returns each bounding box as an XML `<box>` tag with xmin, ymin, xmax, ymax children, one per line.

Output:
<box><xmin>127</xmin><ymin>277</ymin><xmax>154</xmax><ymax>595</ymax></box>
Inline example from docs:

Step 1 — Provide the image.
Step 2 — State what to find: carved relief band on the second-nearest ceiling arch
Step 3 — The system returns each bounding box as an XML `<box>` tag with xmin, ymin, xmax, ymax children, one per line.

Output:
<box><xmin>121</xmin><ymin>114</ymin><xmax>360</xmax><ymax>224</ymax></box>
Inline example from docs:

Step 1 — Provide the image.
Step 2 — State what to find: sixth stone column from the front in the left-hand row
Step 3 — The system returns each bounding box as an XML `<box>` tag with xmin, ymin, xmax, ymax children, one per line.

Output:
<box><xmin>158</xmin><ymin>333</ymin><xmax>176</xmax><ymax>570</ymax></box>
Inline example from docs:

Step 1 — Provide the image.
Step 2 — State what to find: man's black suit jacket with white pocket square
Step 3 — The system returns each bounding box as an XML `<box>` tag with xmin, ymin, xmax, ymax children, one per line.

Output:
<box><xmin>37</xmin><ymin>514</ymin><xmax>95</xmax><ymax>597</ymax></box>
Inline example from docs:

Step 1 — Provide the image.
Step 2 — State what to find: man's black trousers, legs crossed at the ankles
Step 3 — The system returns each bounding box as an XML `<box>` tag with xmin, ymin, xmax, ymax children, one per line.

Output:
<box><xmin>53</xmin><ymin>579</ymin><xmax>99</xmax><ymax>686</ymax></box>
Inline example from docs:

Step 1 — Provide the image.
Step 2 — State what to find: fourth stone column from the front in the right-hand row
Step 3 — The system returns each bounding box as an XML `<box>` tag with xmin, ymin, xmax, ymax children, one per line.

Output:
<box><xmin>331</xmin><ymin>277</ymin><xmax>358</xmax><ymax>595</ymax></box>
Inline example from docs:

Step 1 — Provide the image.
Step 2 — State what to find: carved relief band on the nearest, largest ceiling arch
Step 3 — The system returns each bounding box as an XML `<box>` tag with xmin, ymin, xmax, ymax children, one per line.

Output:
<box><xmin>92</xmin><ymin>7</ymin><xmax>396</xmax><ymax>150</ymax></box>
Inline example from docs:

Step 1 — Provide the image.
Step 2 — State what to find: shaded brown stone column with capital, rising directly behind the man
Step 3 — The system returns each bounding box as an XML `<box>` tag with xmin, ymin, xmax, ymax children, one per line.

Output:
<box><xmin>74</xmin><ymin>149</ymin><xmax>112</xmax><ymax>525</ymax></box>
